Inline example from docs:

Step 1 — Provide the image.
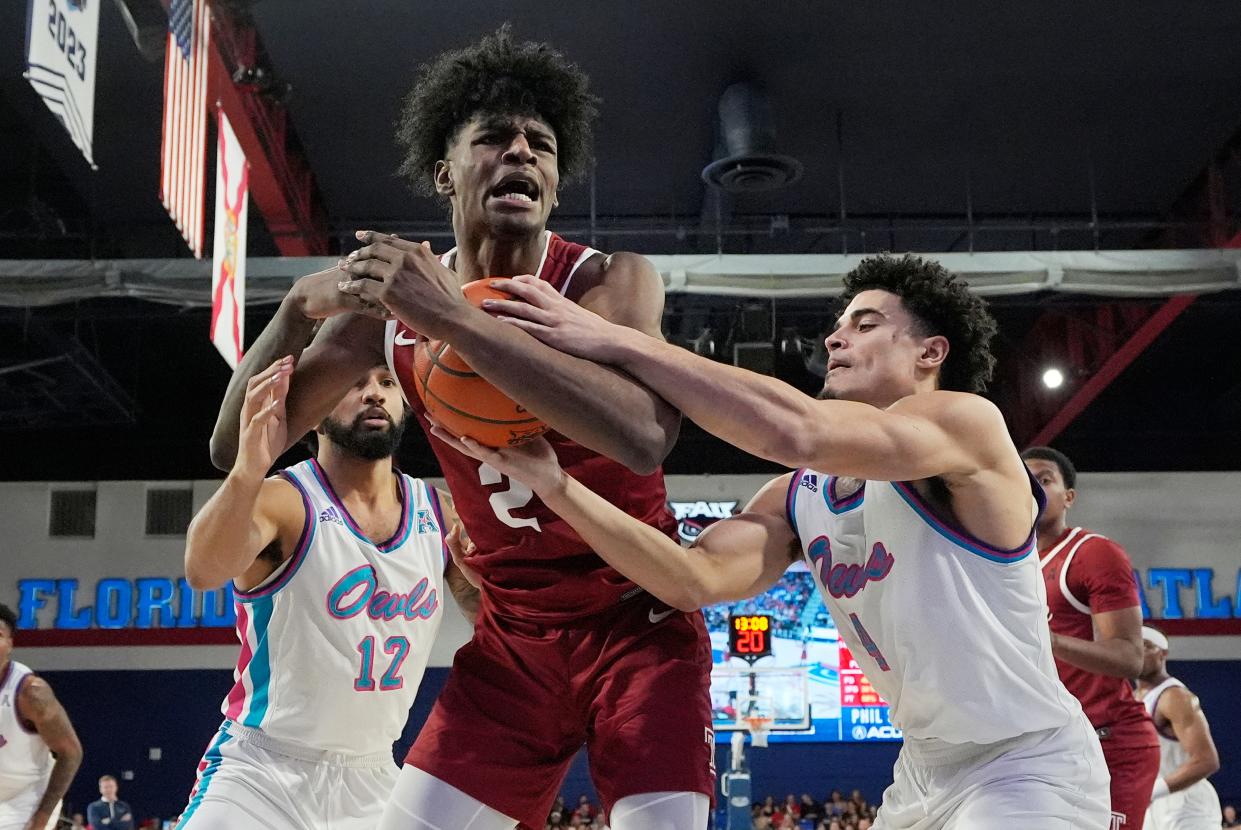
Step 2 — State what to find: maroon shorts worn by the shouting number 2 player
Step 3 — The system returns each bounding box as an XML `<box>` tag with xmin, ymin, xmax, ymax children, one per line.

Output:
<box><xmin>406</xmin><ymin>593</ymin><xmax>715</xmax><ymax>828</ymax></box>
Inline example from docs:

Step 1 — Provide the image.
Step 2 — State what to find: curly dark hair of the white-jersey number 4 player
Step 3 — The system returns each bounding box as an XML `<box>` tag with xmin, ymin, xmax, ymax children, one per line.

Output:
<box><xmin>841</xmin><ymin>253</ymin><xmax>995</xmax><ymax>393</ymax></box>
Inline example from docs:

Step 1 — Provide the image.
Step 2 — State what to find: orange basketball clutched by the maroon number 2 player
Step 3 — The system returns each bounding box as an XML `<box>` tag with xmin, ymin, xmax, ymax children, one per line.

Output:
<box><xmin>413</xmin><ymin>279</ymin><xmax>547</xmax><ymax>447</ymax></box>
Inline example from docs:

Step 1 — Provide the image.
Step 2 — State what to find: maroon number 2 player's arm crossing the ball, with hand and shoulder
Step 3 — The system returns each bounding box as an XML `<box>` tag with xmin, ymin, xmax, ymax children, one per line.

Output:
<box><xmin>344</xmin><ymin>231</ymin><xmax>680</xmax><ymax>474</ymax></box>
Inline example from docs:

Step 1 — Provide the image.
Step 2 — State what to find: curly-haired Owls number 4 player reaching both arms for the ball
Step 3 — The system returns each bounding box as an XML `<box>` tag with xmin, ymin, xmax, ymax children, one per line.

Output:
<box><xmin>441</xmin><ymin>257</ymin><xmax>1109</xmax><ymax>830</ymax></box>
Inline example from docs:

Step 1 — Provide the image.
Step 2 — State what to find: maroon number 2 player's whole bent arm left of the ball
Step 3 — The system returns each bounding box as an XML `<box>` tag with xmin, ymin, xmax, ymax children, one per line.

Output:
<box><xmin>211</xmin><ymin>268</ymin><xmax>390</xmax><ymax>473</ymax></box>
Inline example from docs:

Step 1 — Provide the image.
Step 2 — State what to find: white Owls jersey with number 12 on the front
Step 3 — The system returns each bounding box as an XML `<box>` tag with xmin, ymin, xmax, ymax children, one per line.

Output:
<box><xmin>221</xmin><ymin>459</ymin><xmax>448</xmax><ymax>756</ymax></box>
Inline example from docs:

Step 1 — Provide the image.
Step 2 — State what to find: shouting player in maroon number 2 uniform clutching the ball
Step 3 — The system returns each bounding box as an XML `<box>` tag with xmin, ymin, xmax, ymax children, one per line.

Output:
<box><xmin>212</xmin><ymin>30</ymin><xmax>715</xmax><ymax>830</ymax></box>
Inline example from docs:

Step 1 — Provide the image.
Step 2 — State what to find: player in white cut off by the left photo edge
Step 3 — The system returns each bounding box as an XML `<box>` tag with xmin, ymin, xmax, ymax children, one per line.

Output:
<box><xmin>0</xmin><ymin>605</ymin><xmax>82</xmax><ymax>830</ymax></box>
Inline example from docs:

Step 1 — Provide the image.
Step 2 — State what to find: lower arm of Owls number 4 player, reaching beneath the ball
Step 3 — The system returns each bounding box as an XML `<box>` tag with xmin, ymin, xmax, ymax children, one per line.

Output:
<box><xmin>434</xmin><ymin>427</ymin><xmax>799</xmax><ymax>610</ymax></box>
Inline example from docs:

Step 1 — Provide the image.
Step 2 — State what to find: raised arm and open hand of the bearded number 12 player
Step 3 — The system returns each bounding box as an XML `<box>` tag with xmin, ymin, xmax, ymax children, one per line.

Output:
<box><xmin>185</xmin><ymin>360</ymin><xmax>305</xmax><ymax>591</ymax></box>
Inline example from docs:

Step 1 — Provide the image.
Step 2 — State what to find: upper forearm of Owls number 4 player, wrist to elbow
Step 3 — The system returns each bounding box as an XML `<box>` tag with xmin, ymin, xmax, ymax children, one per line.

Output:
<box><xmin>617</xmin><ymin>332</ymin><xmax>818</xmax><ymax>466</ymax></box>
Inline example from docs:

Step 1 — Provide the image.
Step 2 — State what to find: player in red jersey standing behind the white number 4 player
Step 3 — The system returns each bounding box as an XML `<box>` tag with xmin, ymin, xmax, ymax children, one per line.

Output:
<box><xmin>1021</xmin><ymin>447</ymin><xmax>1159</xmax><ymax>830</ymax></box>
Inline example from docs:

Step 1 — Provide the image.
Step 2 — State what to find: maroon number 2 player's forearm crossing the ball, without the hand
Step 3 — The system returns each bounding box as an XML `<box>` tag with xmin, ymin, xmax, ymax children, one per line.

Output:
<box><xmin>446</xmin><ymin>309</ymin><xmax>680</xmax><ymax>474</ymax></box>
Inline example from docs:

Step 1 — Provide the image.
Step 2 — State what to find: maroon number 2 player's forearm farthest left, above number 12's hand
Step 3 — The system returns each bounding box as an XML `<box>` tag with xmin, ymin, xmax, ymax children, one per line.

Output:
<box><xmin>211</xmin><ymin>292</ymin><xmax>316</xmax><ymax>473</ymax></box>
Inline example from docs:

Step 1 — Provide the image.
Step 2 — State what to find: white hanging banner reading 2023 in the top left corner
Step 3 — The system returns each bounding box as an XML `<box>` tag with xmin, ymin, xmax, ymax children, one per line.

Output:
<box><xmin>22</xmin><ymin>0</ymin><xmax>103</xmax><ymax>170</ymax></box>
